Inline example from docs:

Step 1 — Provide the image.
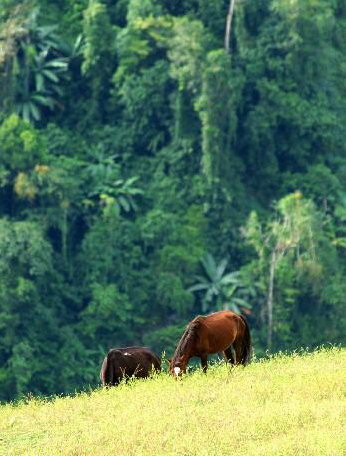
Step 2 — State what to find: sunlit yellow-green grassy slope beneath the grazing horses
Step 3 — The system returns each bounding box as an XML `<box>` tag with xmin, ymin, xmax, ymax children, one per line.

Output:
<box><xmin>0</xmin><ymin>349</ymin><xmax>346</xmax><ymax>456</ymax></box>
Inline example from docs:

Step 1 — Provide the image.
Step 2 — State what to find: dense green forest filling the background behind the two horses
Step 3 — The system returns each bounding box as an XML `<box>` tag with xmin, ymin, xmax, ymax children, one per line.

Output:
<box><xmin>0</xmin><ymin>0</ymin><xmax>346</xmax><ymax>400</ymax></box>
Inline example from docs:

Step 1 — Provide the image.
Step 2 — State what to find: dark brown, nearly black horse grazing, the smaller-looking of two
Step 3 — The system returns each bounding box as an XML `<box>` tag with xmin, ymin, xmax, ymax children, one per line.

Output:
<box><xmin>100</xmin><ymin>347</ymin><xmax>161</xmax><ymax>386</ymax></box>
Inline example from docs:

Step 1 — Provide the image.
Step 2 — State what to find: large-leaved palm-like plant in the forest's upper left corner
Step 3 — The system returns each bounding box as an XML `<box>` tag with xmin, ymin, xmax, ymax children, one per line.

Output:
<box><xmin>0</xmin><ymin>9</ymin><xmax>68</xmax><ymax>123</ymax></box>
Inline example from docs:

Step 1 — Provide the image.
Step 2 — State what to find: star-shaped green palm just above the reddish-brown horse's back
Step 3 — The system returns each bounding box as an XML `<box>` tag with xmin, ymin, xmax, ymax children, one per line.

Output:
<box><xmin>189</xmin><ymin>253</ymin><xmax>254</xmax><ymax>313</ymax></box>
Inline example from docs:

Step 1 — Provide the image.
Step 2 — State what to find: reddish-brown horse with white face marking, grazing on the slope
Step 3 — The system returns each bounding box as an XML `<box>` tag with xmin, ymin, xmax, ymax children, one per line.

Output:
<box><xmin>169</xmin><ymin>310</ymin><xmax>251</xmax><ymax>376</ymax></box>
